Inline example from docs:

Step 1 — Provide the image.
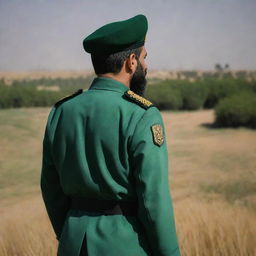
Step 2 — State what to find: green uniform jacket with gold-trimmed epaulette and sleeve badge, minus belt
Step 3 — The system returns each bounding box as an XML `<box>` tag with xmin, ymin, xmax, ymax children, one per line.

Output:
<box><xmin>41</xmin><ymin>77</ymin><xmax>180</xmax><ymax>256</ymax></box>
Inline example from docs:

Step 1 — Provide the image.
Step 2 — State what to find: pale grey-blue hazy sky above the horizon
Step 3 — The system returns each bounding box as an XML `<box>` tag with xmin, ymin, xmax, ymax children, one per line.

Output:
<box><xmin>0</xmin><ymin>0</ymin><xmax>256</xmax><ymax>72</ymax></box>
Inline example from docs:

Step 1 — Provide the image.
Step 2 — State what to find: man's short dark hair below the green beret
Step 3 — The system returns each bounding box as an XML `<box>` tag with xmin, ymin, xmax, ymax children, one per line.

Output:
<box><xmin>91</xmin><ymin>47</ymin><xmax>142</xmax><ymax>75</ymax></box>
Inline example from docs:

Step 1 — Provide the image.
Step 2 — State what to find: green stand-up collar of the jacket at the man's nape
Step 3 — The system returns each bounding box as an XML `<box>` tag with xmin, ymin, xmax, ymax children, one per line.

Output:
<box><xmin>89</xmin><ymin>77</ymin><xmax>129</xmax><ymax>93</ymax></box>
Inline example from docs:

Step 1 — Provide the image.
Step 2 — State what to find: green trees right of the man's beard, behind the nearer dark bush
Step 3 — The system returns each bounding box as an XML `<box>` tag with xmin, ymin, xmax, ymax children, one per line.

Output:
<box><xmin>146</xmin><ymin>78</ymin><xmax>256</xmax><ymax>110</ymax></box>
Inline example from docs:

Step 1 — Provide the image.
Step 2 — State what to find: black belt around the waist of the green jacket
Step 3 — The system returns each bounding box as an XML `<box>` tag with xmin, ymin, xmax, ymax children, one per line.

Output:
<box><xmin>71</xmin><ymin>197</ymin><xmax>138</xmax><ymax>216</ymax></box>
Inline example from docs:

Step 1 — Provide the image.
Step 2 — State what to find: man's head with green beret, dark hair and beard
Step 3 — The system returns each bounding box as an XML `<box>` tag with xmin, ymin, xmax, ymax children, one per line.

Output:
<box><xmin>83</xmin><ymin>15</ymin><xmax>148</xmax><ymax>95</ymax></box>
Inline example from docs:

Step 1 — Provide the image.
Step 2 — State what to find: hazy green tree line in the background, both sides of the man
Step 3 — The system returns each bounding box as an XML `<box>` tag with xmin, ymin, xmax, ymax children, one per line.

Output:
<box><xmin>0</xmin><ymin>74</ymin><xmax>256</xmax><ymax>116</ymax></box>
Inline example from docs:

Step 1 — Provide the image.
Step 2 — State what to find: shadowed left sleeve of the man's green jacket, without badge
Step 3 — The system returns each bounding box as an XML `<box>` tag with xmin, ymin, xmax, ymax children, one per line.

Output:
<box><xmin>41</xmin><ymin>110</ymin><xmax>70</xmax><ymax>240</ymax></box>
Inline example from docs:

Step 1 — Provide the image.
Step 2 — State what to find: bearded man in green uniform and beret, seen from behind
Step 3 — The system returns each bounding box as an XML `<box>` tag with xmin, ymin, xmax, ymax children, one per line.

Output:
<box><xmin>41</xmin><ymin>15</ymin><xmax>180</xmax><ymax>256</ymax></box>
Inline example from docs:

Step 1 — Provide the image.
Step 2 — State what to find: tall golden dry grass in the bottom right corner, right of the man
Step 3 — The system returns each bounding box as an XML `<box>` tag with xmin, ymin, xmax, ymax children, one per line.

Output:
<box><xmin>175</xmin><ymin>200</ymin><xmax>256</xmax><ymax>256</ymax></box>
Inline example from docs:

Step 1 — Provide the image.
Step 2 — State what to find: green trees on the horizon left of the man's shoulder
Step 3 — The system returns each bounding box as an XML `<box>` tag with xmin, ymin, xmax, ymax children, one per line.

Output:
<box><xmin>0</xmin><ymin>77</ymin><xmax>92</xmax><ymax>109</ymax></box>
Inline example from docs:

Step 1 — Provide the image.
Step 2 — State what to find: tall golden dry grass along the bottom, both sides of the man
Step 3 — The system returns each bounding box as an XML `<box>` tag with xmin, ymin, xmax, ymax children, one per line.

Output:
<box><xmin>0</xmin><ymin>198</ymin><xmax>256</xmax><ymax>256</ymax></box>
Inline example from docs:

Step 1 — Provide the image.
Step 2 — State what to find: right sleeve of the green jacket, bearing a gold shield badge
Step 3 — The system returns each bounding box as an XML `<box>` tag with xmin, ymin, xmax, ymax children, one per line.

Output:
<box><xmin>131</xmin><ymin>107</ymin><xmax>180</xmax><ymax>256</ymax></box>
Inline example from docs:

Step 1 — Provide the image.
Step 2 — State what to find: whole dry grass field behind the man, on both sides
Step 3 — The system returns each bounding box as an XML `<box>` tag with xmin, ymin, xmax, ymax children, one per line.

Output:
<box><xmin>0</xmin><ymin>108</ymin><xmax>256</xmax><ymax>256</ymax></box>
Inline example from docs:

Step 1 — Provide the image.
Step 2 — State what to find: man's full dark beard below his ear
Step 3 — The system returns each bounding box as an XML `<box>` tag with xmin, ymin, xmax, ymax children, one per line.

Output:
<box><xmin>130</xmin><ymin>61</ymin><xmax>147</xmax><ymax>96</ymax></box>
